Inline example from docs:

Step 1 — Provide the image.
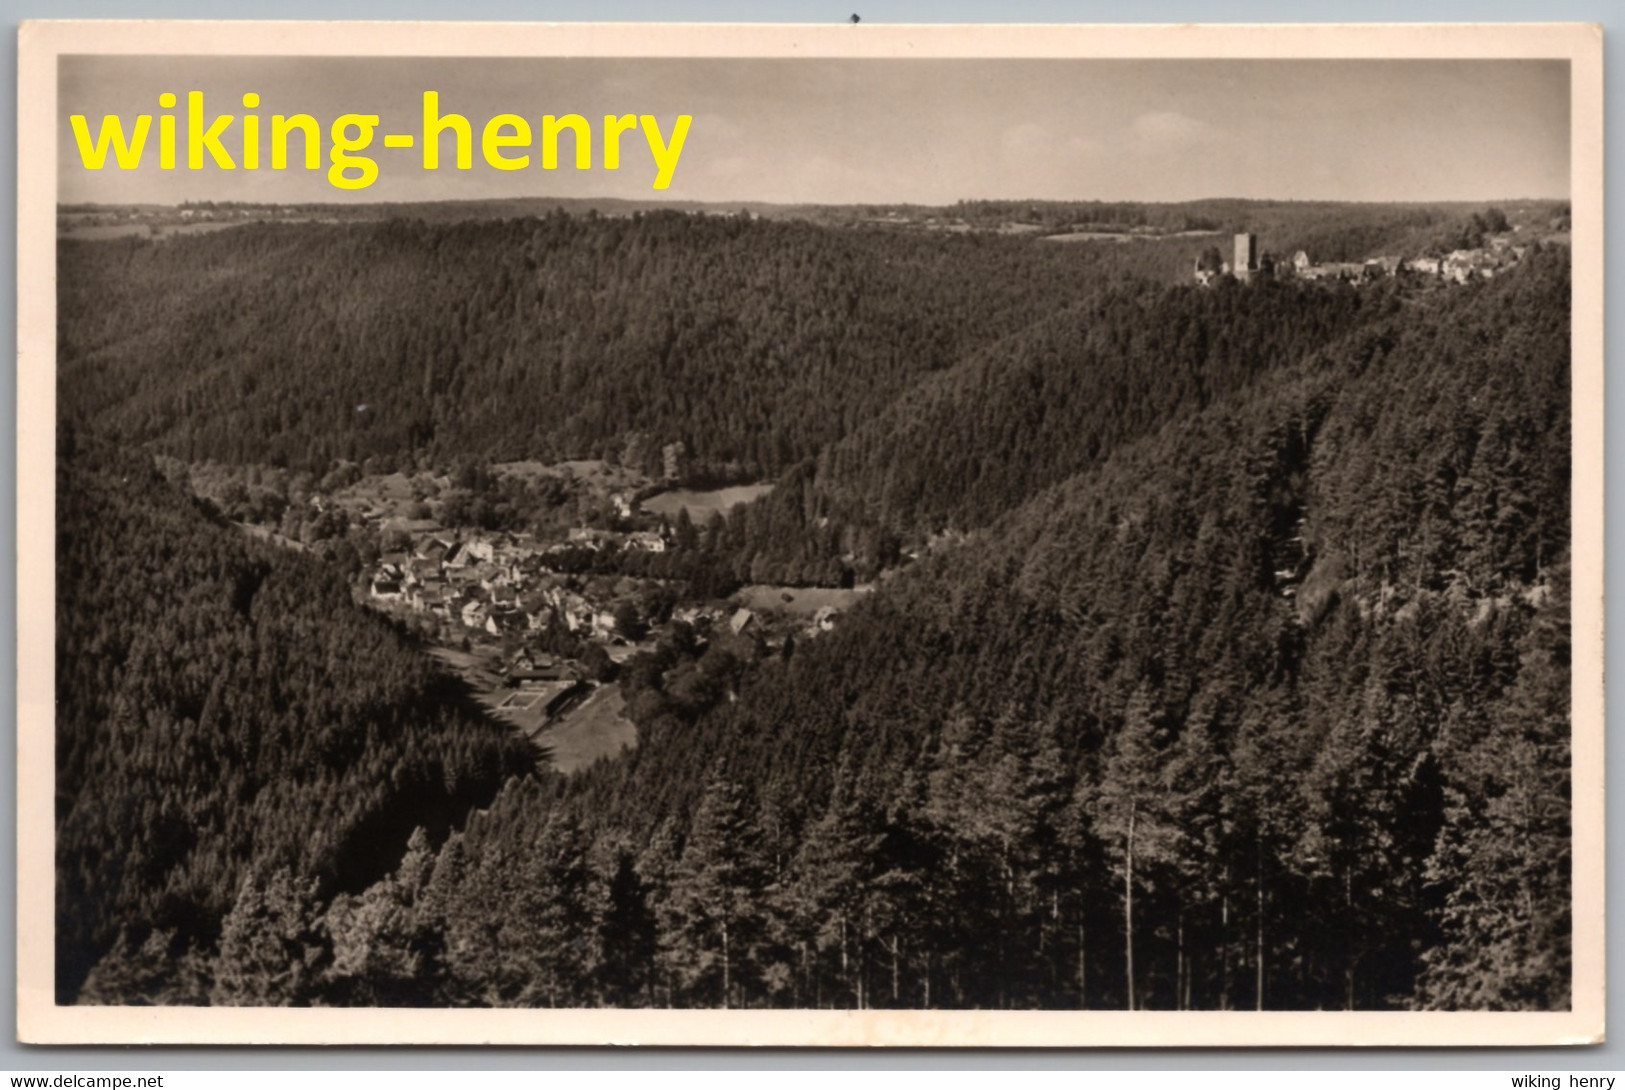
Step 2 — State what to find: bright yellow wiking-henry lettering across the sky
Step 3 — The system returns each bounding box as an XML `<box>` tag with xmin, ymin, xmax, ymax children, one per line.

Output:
<box><xmin>68</xmin><ymin>91</ymin><xmax>694</xmax><ymax>190</ymax></box>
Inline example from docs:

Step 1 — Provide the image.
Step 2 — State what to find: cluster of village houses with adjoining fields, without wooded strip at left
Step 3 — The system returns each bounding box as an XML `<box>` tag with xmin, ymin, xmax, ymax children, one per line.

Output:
<box><xmin>361</xmin><ymin>474</ymin><xmax>861</xmax><ymax>772</ymax></box>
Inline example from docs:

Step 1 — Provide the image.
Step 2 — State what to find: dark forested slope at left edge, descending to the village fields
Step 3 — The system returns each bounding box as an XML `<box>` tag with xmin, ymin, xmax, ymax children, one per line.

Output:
<box><xmin>57</xmin><ymin>438</ymin><xmax>535</xmax><ymax>1002</ymax></box>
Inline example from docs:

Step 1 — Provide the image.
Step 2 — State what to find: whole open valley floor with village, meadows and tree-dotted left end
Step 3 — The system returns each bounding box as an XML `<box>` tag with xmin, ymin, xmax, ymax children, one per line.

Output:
<box><xmin>167</xmin><ymin>443</ymin><xmax>869</xmax><ymax>772</ymax></box>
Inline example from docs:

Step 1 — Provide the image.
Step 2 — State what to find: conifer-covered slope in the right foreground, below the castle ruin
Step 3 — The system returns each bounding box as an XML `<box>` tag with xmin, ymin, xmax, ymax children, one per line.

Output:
<box><xmin>396</xmin><ymin>253</ymin><xmax>1570</xmax><ymax>1009</ymax></box>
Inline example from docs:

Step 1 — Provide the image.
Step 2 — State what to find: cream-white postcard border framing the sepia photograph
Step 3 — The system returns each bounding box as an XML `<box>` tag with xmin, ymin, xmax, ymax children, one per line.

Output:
<box><xmin>16</xmin><ymin>21</ymin><xmax>1606</xmax><ymax>1048</ymax></box>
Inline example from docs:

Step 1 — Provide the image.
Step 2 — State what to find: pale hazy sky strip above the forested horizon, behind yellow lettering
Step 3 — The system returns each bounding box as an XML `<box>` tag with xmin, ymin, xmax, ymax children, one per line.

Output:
<box><xmin>57</xmin><ymin>55</ymin><xmax>1570</xmax><ymax>205</ymax></box>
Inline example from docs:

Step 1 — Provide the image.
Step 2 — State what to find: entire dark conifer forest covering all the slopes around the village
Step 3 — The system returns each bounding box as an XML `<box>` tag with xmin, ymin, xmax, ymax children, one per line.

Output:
<box><xmin>57</xmin><ymin>206</ymin><xmax>1571</xmax><ymax>1009</ymax></box>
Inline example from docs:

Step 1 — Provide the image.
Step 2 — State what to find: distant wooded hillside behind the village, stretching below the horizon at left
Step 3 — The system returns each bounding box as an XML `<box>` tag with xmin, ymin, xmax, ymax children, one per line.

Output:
<box><xmin>59</xmin><ymin>213</ymin><xmax>1183</xmax><ymax>479</ymax></box>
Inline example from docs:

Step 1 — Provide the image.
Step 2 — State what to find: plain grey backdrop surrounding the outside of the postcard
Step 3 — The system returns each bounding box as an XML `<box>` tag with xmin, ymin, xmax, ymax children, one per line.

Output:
<box><xmin>0</xmin><ymin>0</ymin><xmax>1625</xmax><ymax>1072</ymax></box>
